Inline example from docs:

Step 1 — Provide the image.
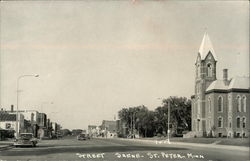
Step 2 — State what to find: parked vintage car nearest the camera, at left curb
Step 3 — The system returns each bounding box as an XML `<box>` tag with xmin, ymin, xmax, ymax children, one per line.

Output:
<box><xmin>14</xmin><ymin>133</ymin><xmax>38</xmax><ymax>147</ymax></box>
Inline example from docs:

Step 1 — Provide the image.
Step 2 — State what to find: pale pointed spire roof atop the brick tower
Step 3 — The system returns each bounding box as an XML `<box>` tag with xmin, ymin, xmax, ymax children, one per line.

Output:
<box><xmin>199</xmin><ymin>32</ymin><xmax>217</xmax><ymax>61</ymax></box>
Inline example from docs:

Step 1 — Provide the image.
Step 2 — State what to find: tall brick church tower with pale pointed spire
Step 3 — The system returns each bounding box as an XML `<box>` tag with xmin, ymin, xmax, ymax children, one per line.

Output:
<box><xmin>192</xmin><ymin>33</ymin><xmax>217</xmax><ymax>135</ymax></box>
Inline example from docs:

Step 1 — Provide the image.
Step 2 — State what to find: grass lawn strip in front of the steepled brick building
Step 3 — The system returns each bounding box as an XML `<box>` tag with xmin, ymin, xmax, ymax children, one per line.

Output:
<box><xmin>140</xmin><ymin>137</ymin><xmax>250</xmax><ymax>147</ymax></box>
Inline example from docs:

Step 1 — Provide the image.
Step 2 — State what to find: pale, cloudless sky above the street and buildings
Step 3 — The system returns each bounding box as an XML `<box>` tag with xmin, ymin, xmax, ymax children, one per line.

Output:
<box><xmin>0</xmin><ymin>0</ymin><xmax>249</xmax><ymax>129</ymax></box>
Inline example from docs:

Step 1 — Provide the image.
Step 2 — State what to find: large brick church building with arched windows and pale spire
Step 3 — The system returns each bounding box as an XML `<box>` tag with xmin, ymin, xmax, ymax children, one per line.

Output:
<box><xmin>189</xmin><ymin>33</ymin><xmax>250</xmax><ymax>137</ymax></box>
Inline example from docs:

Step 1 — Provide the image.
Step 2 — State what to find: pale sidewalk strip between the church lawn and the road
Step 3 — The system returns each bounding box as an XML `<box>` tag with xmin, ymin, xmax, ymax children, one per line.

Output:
<box><xmin>117</xmin><ymin>138</ymin><xmax>249</xmax><ymax>152</ymax></box>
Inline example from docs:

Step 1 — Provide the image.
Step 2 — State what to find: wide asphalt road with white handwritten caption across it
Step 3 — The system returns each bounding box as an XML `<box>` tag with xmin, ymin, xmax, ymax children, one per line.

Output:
<box><xmin>0</xmin><ymin>138</ymin><xmax>249</xmax><ymax>161</ymax></box>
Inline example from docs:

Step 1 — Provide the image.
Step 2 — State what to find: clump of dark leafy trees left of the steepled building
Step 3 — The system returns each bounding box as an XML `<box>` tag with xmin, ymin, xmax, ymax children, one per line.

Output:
<box><xmin>118</xmin><ymin>97</ymin><xmax>191</xmax><ymax>137</ymax></box>
